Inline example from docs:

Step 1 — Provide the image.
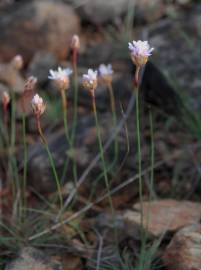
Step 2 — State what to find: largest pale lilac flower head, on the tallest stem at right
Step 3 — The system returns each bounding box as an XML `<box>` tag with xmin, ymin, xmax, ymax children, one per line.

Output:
<box><xmin>128</xmin><ymin>40</ymin><xmax>154</xmax><ymax>67</ymax></box>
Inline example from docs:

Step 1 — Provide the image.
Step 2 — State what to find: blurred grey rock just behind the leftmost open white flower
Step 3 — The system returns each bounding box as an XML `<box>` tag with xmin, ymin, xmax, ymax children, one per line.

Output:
<box><xmin>27</xmin><ymin>51</ymin><xmax>58</xmax><ymax>84</ymax></box>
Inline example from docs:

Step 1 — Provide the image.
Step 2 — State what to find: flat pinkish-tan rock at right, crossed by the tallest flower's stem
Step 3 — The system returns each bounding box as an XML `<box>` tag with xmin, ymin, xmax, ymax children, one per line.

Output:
<box><xmin>123</xmin><ymin>200</ymin><xmax>201</xmax><ymax>236</ymax></box>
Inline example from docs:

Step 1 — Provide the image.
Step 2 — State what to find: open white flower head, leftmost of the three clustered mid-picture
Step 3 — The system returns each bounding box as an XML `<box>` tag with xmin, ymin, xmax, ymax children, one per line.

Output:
<box><xmin>48</xmin><ymin>67</ymin><xmax>73</xmax><ymax>90</ymax></box>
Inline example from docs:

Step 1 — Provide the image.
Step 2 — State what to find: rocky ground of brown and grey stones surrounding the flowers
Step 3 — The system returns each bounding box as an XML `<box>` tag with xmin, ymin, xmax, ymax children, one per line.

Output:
<box><xmin>0</xmin><ymin>0</ymin><xmax>201</xmax><ymax>270</ymax></box>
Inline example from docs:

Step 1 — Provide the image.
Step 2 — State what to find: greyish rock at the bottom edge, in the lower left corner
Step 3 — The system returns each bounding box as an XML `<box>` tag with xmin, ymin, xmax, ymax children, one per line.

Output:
<box><xmin>5</xmin><ymin>247</ymin><xmax>63</xmax><ymax>270</ymax></box>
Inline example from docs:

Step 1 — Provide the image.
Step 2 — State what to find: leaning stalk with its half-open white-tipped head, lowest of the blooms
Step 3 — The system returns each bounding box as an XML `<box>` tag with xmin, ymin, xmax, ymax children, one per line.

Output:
<box><xmin>32</xmin><ymin>95</ymin><xmax>63</xmax><ymax>208</ymax></box>
